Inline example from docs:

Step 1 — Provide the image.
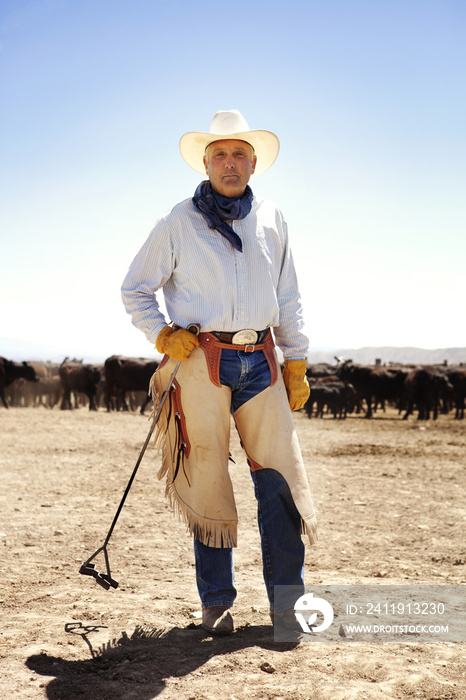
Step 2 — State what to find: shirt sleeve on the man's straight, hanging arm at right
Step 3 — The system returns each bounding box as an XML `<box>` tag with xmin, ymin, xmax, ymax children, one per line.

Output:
<box><xmin>273</xmin><ymin>213</ymin><xmax>309</xmax><ymax>360</ymax></box>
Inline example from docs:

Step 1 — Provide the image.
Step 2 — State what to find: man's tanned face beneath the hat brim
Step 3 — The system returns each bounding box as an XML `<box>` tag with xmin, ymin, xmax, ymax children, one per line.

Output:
<box><xmin>204</xmin><ymin>139</ymin><xmax>257</xmax><ymax>197</ymax></box>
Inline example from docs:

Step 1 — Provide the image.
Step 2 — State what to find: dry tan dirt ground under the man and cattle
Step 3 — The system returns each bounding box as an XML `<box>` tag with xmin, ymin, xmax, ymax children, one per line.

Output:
<box><xmin>0</xmin><ymin>408</ymin><xmax>466</xmax><ymax>700</ymax></box>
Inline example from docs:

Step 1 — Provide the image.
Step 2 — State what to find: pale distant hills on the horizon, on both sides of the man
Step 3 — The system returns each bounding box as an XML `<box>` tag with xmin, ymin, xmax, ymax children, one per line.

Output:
<box><xmin>0</xmin><ymin>338</ymin><xmax>466</xmax><ymax>365</ymax></box>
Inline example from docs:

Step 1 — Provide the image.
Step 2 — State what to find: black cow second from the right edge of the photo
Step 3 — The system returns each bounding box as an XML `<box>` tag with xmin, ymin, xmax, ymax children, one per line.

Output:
<box><xmin>403</xmin><ymin>367</ymin><xmax>453</xmax><ymax>420</ymax></box>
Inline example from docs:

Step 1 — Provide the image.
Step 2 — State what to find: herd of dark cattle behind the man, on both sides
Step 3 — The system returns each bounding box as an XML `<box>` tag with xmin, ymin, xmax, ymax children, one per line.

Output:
<box><xmin>0</xmin><ymin>355</ymin><xmax>466</xmax><ymax>420</ymax></box>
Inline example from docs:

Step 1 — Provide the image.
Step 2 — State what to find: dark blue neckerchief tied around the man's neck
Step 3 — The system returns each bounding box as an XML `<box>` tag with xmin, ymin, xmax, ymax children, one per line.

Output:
<box><xmin>193</xmin><ymin>180</ymin><xmax>253</xmax><ymax>253</ymax></box>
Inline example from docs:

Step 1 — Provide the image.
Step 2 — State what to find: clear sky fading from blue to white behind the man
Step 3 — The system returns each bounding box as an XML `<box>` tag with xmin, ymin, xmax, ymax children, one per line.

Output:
<box><xmin>0</xmin><ymin>0</ymin><xmax>466</xmax><ymax>360</ymax></box>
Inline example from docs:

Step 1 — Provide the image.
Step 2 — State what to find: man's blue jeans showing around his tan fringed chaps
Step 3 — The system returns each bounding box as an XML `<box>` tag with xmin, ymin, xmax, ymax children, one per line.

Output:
<box><xmin>194</xmin><ymin>350</ymin><xmax>304</xmax><ymax>610</ymax></box>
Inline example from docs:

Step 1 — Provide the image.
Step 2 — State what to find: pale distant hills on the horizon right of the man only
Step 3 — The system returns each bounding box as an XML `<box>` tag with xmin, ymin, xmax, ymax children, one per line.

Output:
<box><xmin>308</xmin><ymin>347</ymin><xmax>466</xmax><ymax>365</ymax></box>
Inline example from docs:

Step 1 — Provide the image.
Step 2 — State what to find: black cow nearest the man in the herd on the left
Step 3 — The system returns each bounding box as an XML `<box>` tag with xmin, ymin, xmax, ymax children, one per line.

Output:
<box><xmin>105</xmin><ymin>355</ymin><xmax>159</xmax><ymax>414</ymax></box>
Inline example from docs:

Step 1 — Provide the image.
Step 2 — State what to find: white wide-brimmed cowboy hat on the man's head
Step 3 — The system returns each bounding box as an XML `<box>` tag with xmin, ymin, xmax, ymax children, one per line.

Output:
<box><xmin>180</xmin><ymin>109</ymin><xmax>280</xmax><ymax>175</ymax></box>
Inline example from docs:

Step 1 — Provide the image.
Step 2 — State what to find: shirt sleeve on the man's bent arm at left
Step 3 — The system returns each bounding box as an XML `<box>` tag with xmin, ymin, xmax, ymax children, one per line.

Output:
<box><xmin>121</xmin><ymin>219</ymin><xmax>174</xmax><ymax>345</ymax></box>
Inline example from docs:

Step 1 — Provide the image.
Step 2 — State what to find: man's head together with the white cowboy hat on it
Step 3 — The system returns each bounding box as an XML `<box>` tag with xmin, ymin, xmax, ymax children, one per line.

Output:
<box><xmin>180</xmin><ymin>109</ymin><xmax>280</xmax><ymax>185</ymax></box>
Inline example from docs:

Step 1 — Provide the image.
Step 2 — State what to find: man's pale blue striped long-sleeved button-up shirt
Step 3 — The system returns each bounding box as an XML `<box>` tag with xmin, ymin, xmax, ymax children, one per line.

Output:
<box><xmin>121</xmin><ymin>197</ymin><xmax>308</xmax><ymax>360</ymax></box>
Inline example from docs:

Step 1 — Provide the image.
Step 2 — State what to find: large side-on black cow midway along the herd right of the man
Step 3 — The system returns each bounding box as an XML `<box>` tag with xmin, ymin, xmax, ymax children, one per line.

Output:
<box><xmin>336</xmin><ymin>361</ymin><xmax>408</xmax><ymax>418</ymax></box>
